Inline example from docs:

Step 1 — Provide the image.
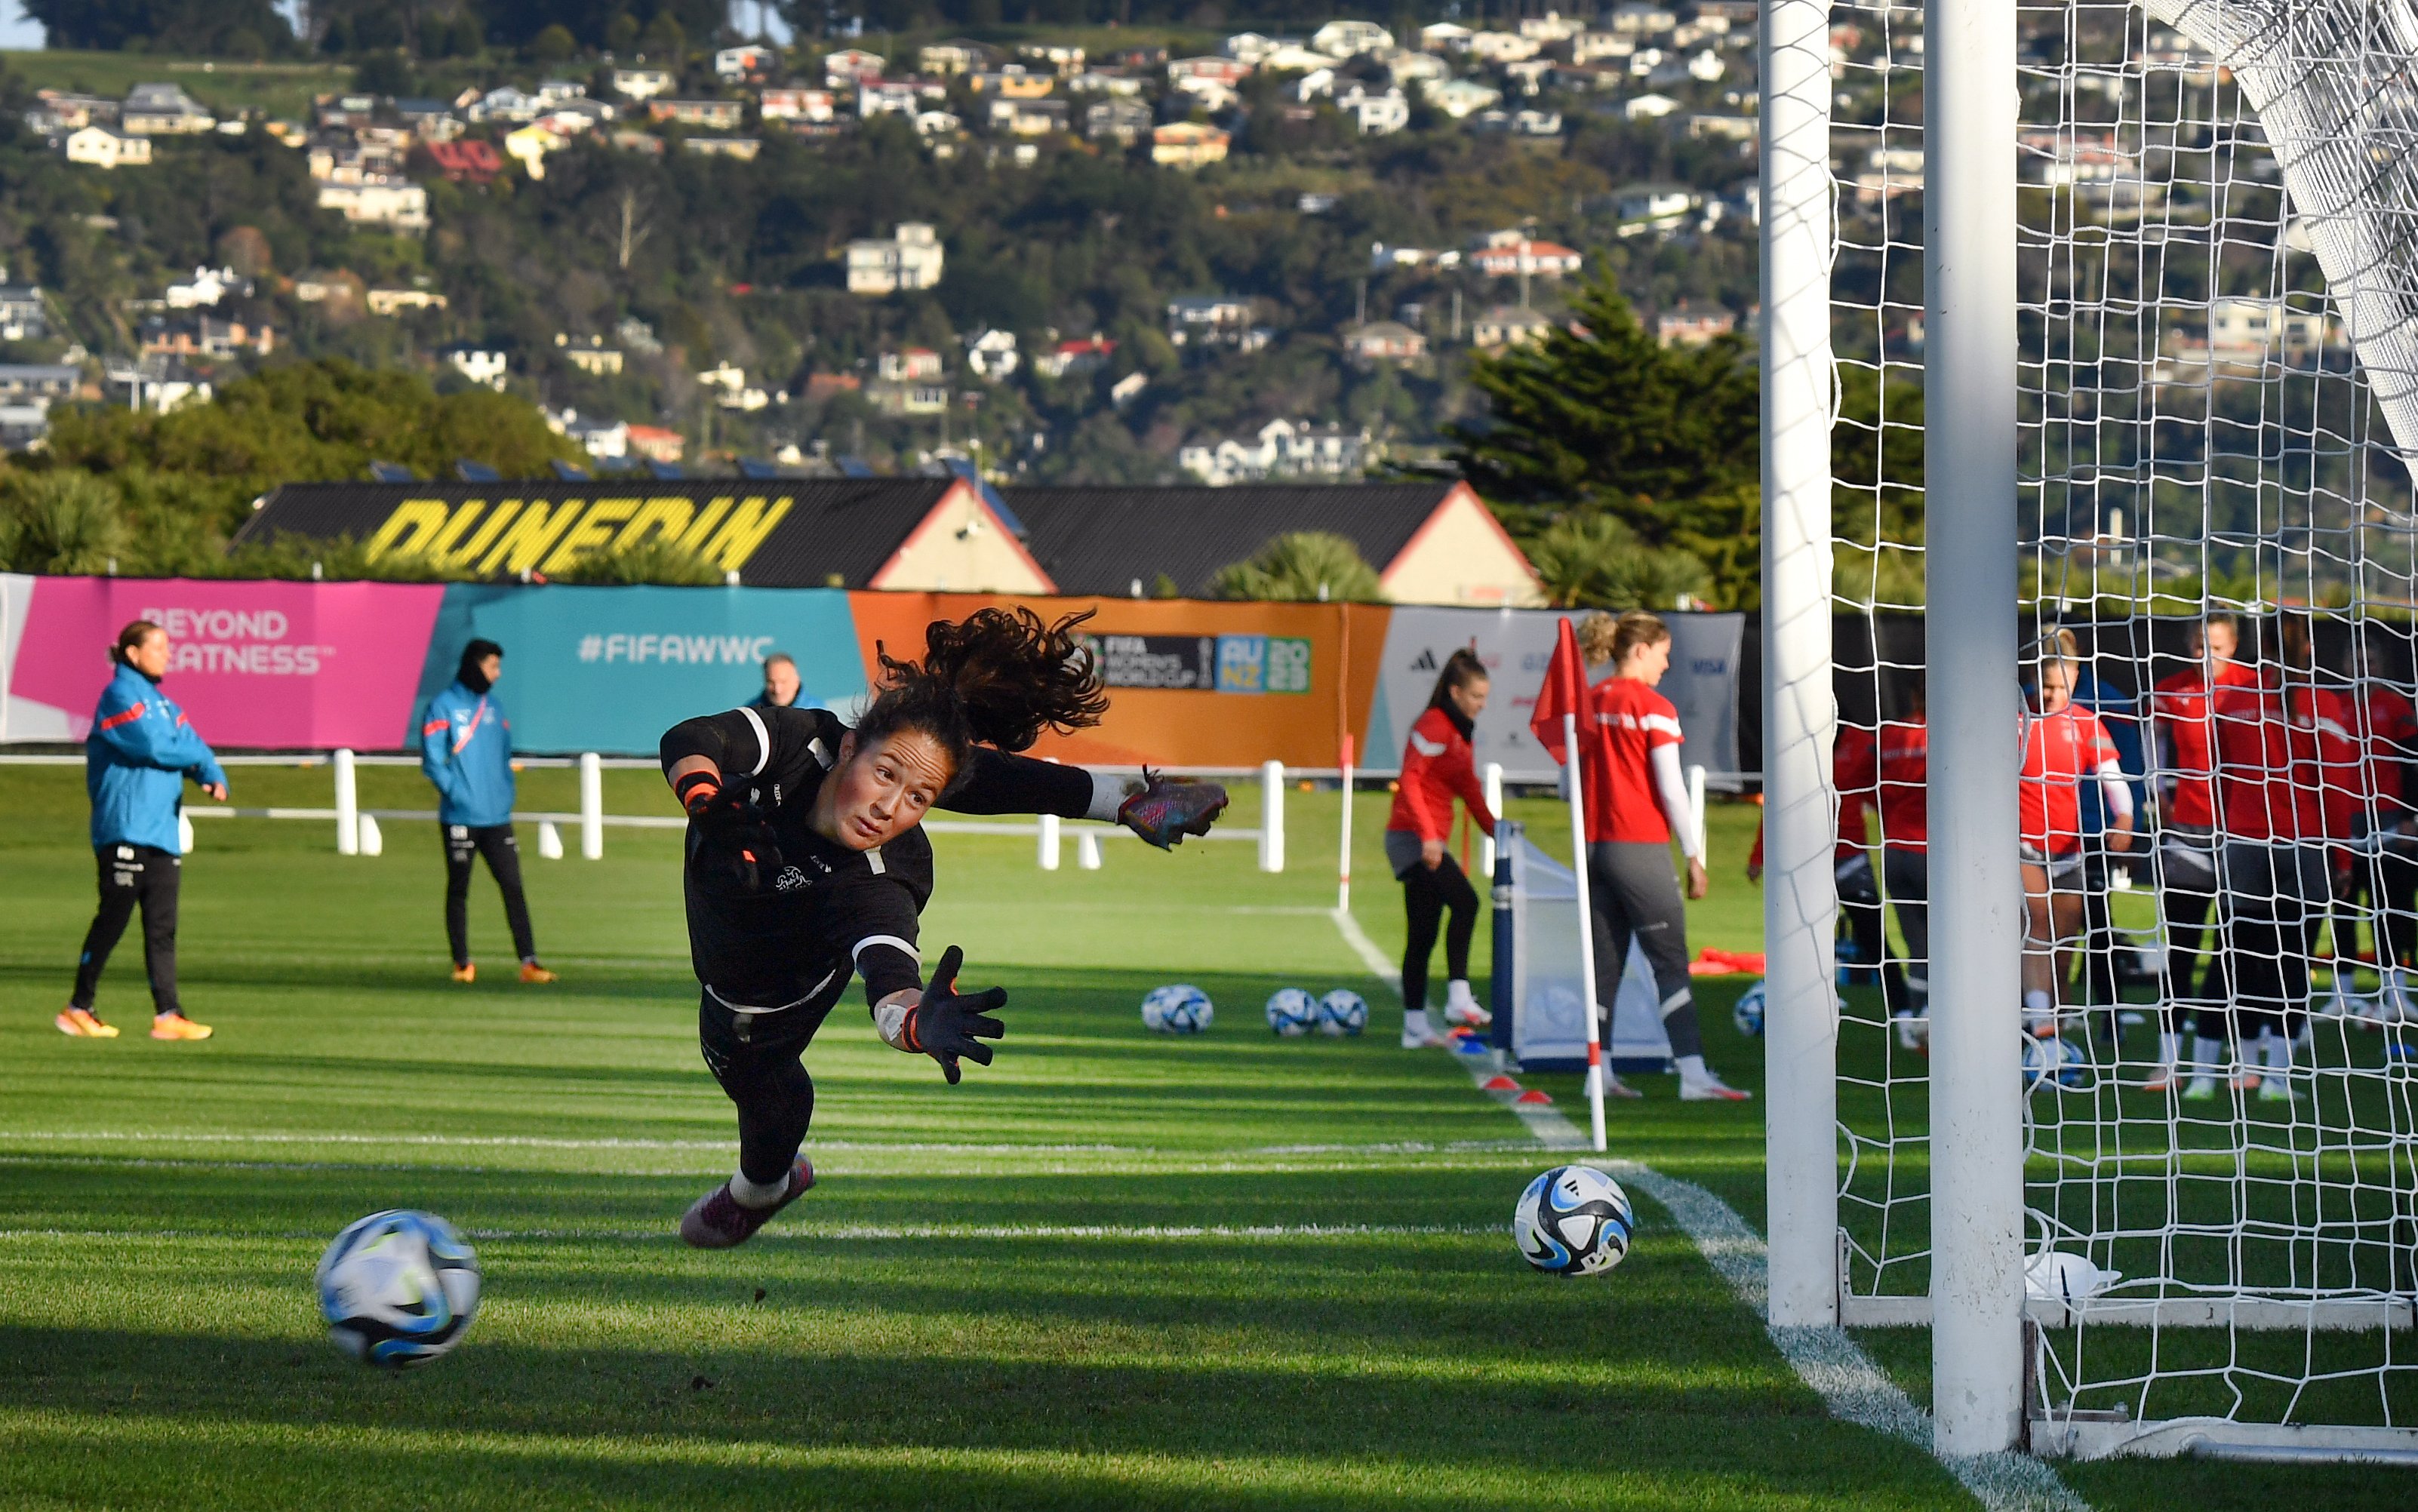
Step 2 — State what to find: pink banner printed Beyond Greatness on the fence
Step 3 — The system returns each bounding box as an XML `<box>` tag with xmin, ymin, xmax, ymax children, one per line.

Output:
<box><xmin>10</xmin><ymin>578</ymin><xmax>445</xmax><ymax>750</ymax></box>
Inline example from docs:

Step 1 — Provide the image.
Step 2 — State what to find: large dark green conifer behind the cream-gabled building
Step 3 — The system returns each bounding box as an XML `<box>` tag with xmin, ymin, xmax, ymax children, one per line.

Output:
<box><xmin>1448</xmin><ymin>278</ymin><xmax>1763</xmax><ymax>544</ymax></box>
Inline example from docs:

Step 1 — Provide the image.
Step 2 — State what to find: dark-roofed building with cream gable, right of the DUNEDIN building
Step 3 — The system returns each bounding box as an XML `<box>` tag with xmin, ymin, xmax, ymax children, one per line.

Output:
<box><xmin>1001</xmin><ymin>479</ymin><xmax>1545</xmax><ymax>607</ymax></box>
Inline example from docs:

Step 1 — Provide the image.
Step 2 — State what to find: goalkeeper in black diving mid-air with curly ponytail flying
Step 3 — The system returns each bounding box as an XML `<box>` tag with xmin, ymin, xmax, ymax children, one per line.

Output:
<box><xmin>663</xmin><ymin>607</ymin><xmax>1226</xmax><ymax>1249</ymax></box>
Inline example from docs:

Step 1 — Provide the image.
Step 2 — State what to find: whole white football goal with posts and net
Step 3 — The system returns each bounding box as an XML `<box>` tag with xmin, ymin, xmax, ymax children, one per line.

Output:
<box><xmin>1761</xmin><ymin>0</ymin><xmax>2418</xmax><ymax>1461</ymax></box>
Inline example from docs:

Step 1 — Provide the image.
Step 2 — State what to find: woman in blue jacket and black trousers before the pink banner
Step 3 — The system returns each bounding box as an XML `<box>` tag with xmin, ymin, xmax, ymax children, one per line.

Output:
<box><xmin>53</xmin><ymin>619</ymin><xmax>227</xmax><ymax>1040</ymax></box>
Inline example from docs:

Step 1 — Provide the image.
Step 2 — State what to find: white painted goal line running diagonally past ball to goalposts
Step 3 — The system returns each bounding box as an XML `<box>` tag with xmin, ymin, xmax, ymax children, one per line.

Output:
<box><xmin>1332</xmin><ymin>910</ymin><xmax>2089</xmax><ymax>1512</ymax></box>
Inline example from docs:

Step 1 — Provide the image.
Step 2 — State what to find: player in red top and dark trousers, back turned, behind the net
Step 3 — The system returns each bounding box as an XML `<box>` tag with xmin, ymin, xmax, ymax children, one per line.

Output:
<box><xmin>2183</xmin><ymin>617</ymin><xmax>2358</xmax><ymax>1101</ymax></box>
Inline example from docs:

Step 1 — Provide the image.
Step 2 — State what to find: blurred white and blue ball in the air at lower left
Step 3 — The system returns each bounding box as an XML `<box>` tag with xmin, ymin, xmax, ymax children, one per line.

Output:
<box><xmin>317</xmin><ymin>1207</ymin><xmax>478</xmax><ymax>1369</ymax></box>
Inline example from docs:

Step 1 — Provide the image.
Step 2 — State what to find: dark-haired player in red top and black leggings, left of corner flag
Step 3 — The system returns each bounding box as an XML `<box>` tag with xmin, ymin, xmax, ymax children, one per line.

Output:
<box><xmin>1386</xmin><ymin>651</ymin><xmax>1494</xmax><ymax>1050</ymax></box>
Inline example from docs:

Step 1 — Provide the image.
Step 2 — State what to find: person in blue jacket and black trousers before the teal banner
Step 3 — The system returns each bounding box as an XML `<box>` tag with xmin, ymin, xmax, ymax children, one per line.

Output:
<box><xmin>420</xmin><ymin>641</ymin><xmax>554</xmax><ymax>982</ymax></box>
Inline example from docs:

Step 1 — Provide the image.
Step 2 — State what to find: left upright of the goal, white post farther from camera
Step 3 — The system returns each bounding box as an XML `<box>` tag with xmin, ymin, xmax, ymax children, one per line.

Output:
<box><xmin>1763</xmin><ymin>0</ymin><xmax>1840</xmax><ymax>1328</ymax></box>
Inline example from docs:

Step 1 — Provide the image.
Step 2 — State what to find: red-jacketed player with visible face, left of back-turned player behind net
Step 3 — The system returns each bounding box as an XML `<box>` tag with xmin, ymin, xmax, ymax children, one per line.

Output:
<box><xmin>2145</xmin><ymin>614</ymin><xmax>2259</xmax><ymax>1091</ymax></box>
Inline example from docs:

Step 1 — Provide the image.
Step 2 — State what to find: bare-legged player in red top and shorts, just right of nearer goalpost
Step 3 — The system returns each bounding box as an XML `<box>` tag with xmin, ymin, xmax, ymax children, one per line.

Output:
<box><xmin>2017</xmin><ymin>629</ymin><xmax>2133</xmax><ymax>1035</ymax></box>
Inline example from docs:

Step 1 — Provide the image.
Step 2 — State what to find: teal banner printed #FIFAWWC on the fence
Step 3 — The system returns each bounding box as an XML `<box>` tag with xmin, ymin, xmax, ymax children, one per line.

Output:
<box><xmin>401</xmin><ymin>583</ymin><xmax>868</xmax><ymax>754</ymax></box>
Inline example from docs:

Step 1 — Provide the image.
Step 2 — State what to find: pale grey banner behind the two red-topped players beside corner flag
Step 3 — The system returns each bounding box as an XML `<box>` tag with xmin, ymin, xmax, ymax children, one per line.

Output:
<box><xmin>1366</xmin><ymin>605</ymin><xmax>1746</xmax><ymax>782</ymax></box>
